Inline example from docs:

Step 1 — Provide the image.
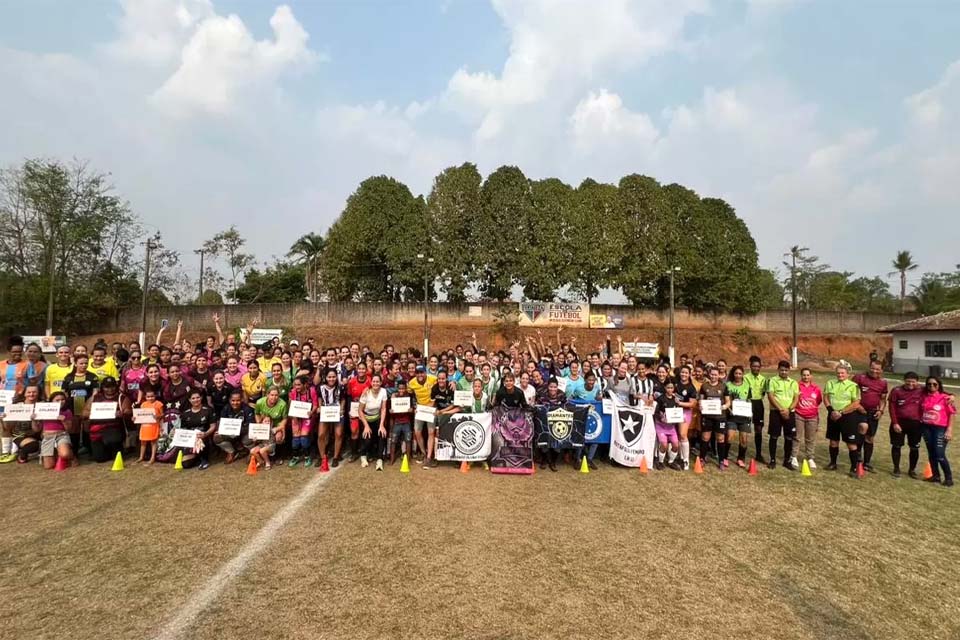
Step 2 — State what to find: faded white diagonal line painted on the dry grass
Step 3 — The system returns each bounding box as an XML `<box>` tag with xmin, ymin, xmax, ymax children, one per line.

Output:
<box><xmin>156</xmin><ymin>470</ymin><xmax>334</xmax><ymax>640</ymax></box>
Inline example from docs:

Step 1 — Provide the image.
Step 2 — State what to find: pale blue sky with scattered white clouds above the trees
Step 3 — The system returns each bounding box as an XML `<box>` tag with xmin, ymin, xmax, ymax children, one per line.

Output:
<box><xmin>0</xmin><ymin>0</ymin><xmax>960</xmax><ymax>300</ymax></box>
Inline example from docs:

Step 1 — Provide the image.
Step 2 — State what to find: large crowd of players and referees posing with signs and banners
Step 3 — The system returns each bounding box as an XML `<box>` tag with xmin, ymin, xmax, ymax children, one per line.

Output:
<box><xmin>0</xmin><ymin>316</ymin><xmax>956</xmax><ymax>486</ymax></box>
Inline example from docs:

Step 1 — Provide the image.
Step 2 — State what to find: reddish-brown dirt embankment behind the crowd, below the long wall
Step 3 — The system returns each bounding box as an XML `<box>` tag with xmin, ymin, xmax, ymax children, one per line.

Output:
<box><xmin>70</xmin><ymin>326</ymin><xmax>890</xmax><ymax>367</ymax></box>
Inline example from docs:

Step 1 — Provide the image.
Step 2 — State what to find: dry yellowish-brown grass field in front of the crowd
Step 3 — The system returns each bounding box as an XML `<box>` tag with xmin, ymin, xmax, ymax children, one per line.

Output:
<box><xmin>0</xmin><ymin>368</ymin><xmax>960</xmax><ymax>640</ymax></box>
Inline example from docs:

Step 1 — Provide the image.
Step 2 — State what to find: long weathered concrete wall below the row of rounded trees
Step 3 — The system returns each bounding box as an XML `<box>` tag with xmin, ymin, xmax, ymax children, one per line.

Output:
<box><xmin>95</xmin><ymin>302</ymin><xmax>915</xmax><ymax>334</ymax></box>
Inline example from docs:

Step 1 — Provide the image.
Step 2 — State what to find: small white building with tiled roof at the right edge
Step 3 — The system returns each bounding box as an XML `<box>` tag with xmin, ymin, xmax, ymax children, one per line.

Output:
<box><xmin>877</xmin><ymin>309</ymin><xmax>960</xmax><ymax>378</ymax></box>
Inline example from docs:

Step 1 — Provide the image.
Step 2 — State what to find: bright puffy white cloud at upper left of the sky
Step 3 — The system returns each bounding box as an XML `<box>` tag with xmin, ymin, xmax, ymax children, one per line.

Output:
<box><xmin>152</xmin><ymin>5</ymin><xmax>317</xmax><ymax>115</ymax></box>
